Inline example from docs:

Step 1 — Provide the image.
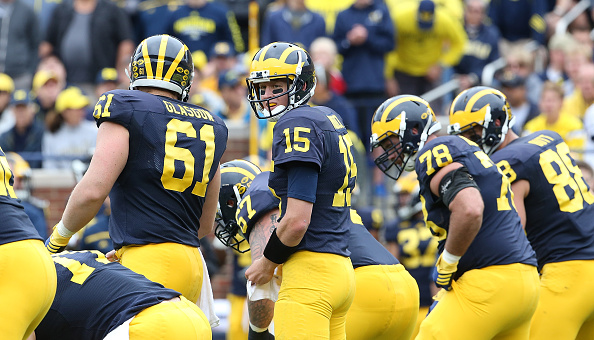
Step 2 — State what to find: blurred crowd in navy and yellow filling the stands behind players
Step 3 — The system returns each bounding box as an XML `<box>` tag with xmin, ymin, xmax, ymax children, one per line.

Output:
<box><xmin>0</xmin><ymin>0</ymin><xmax>594</xmax><ymax>334</ymax></box>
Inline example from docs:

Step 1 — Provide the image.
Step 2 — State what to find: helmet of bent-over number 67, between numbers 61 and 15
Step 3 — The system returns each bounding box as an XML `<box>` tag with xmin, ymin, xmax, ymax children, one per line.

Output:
<box><xmin>214</xmin><ymin>159</ymin><xmax>261</xmax><ymax>253</ymax></box>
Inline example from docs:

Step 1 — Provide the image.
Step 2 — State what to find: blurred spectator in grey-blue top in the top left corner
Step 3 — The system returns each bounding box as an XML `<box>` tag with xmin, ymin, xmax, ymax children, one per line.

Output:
<box><xmin>0</xmin><ymin>0</ymin><xmax>41</xmax><ymax>89</ymax></box>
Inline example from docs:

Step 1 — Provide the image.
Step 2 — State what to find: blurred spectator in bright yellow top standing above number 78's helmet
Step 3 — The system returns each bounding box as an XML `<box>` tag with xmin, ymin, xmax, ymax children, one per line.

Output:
<box><xmin>386</xmin><ymin>0</ymin><xmax>468</xmax><ymax>113</ymax></box>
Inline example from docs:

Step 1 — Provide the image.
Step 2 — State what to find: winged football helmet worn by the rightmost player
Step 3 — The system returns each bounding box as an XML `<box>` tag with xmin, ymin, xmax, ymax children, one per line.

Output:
<box><xmin>448</xmin><ymin>86</ymin><xmax>515</xmax><ymax>155</ymax></box>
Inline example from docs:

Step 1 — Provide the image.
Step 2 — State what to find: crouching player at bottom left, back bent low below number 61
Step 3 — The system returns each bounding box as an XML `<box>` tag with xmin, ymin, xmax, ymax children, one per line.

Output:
<box><xmin>35</xmin><ymin>250</ymin><xmax>212</xmax><ymax>340</ymax></box>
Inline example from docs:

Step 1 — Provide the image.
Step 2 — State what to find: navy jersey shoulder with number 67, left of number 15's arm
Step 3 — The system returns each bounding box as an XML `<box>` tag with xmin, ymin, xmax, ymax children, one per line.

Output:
<box><xmin>235</xmin><ymin>171</ymin><xmax>280</xmax><ymax>241</ymax></box>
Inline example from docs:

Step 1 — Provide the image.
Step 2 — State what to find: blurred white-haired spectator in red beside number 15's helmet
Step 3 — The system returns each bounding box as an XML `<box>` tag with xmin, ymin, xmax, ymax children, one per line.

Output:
<box><xmin>309</xmin><ymin>37</ymin><xmax>346</xmax><ymax>96</ymax></box>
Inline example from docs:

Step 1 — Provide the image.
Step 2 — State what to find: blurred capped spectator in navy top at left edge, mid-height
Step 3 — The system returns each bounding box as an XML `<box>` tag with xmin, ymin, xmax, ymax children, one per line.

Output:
<box><xmin>0</xmin><ymin>90</ymin><xmax>44</xmax><ymax>168</ymax></box>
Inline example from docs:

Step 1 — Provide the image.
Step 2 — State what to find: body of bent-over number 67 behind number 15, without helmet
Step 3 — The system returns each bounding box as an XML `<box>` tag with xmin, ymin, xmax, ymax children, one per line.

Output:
<box><xmin>217</xmin><ymin>172</ymin><xmax>419</xmax><ymax>340</ymax></box>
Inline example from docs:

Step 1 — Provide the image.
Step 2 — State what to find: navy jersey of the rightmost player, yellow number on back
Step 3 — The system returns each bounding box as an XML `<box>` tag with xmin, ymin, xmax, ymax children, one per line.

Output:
<box><xmin>492</xmin><ymin>130</ymin><xmax>594</xmax><ymax>267</ymax></box>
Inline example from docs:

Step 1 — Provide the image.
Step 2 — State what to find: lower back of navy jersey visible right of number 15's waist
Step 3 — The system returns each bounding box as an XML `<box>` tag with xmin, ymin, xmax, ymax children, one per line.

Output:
<box><xmin>349</xmin><ymin>218</ymin><xmax>400</xmax><ymax>268</ymax></box>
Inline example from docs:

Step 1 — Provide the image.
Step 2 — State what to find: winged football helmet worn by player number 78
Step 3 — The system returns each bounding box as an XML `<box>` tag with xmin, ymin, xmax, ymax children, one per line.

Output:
<box><xmin>370</xmin><ymin>95</ymin><xmax>441</xmax><ymax>180</ymax></box>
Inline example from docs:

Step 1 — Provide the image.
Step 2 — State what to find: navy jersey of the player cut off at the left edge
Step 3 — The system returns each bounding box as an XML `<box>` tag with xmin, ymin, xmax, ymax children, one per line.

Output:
<box><xmin>0</xmin><ymin>148</ymin><xmax>42</xmax><ymax>245</ymax></box>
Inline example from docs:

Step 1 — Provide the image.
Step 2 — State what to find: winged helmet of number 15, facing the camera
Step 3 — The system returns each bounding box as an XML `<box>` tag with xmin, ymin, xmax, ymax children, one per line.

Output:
<box><xmin>246</xmin><ymin>42</ymin><xmax>316</xmax><ymax>122</ymax></box>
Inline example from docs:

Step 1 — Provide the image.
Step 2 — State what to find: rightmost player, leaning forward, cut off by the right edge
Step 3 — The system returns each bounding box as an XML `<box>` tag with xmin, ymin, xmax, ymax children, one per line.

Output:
<box><xmin>450</xmin><ymin>86</ymin><xmax>594</xmax><ymax>339</ymax></box>
